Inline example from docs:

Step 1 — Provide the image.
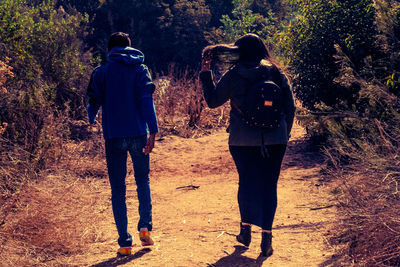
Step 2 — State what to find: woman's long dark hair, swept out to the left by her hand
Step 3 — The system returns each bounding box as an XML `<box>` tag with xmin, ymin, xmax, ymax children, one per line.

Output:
<box><xmin>203</xmin><ymin>33</ymin><xmax>280</xmax><ymax>69</ymax></box>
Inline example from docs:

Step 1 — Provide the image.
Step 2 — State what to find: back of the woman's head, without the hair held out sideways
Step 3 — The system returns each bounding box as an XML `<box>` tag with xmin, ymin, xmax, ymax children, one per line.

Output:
<box><xmin>234</xmin><ymin>33</ymin><xmax>270</xmax><ymax>62</ymax></box>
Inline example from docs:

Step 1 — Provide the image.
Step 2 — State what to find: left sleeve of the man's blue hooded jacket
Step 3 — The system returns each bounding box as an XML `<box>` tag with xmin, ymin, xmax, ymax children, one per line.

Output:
<box><xmin>87</xmin><ymin>68</ymin><xmax>104</xmax><ymax>124</ymax></box>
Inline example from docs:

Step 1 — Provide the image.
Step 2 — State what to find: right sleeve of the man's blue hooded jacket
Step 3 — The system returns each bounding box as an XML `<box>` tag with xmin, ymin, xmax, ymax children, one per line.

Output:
<box><xmin>137</xmin><ymin>65</ymin><xmax>158</xmax><ymax>134</ymax></box>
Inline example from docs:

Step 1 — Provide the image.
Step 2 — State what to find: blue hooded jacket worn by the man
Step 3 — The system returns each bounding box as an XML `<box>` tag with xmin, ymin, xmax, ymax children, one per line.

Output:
<box><xmin>87</xmin><ymin>47</ymin><xmax>158</xmax><ymax>139</ymax></box>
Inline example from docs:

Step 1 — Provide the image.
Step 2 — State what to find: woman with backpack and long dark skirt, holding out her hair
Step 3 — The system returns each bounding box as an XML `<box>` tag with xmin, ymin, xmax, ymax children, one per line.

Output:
<box><xmin>200</xmin><ymin>34</ymin><xmax>295</xmax><ymax>257</ymax></box>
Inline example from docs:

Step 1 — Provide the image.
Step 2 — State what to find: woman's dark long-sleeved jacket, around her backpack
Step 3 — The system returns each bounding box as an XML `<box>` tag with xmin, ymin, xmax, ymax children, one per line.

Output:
<box><xmin>200</xmin><ymin>60</ymin><xmax>296</xmax><ymax>146</ymax></box>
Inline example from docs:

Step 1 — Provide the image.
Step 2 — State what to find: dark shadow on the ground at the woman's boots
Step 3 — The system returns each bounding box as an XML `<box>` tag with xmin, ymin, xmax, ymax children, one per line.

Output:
<box><xmin>208</xmin><ymin>246</ymin><xmax>267</xmax><ymax>267</ymax></box>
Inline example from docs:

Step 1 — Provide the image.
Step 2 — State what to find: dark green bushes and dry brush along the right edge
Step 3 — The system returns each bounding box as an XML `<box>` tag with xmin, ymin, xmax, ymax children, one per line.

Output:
<box><xmin>281</xmin><ymin>0</ymin><xmax>400</xmax><ymax>266</ymax></box>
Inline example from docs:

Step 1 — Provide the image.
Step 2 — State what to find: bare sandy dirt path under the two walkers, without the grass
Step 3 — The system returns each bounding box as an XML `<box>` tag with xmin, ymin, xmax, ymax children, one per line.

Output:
<box><xmin>69</xmin><ymin>126</ymin><xmax>335</xmax><ymax>266</ymax></box>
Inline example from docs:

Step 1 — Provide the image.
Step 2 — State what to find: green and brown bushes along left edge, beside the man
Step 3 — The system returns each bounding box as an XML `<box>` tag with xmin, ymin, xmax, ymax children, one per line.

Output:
<box><xmin>0</xmin><ymin>0</ymin><xmax>92</xmax><ymax>198</ymax></box>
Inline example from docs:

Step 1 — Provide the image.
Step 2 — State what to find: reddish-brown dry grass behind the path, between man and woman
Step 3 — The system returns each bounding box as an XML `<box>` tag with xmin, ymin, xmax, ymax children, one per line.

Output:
<box><xmin>154</xmin><ymin>68</ymin><xmax>230</xmax><ymax>137</ymax></box>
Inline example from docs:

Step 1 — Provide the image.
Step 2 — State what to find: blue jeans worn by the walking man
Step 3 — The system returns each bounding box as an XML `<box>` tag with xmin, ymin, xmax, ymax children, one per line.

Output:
<box><xmin>105</xmin><ymin>135</ymin><xmax>153</xmax><ymax>247</ymax></box>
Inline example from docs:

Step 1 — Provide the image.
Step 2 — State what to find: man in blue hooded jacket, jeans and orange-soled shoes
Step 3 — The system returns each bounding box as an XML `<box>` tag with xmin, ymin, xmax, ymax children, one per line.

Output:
<box><xmin>87</xmin><ymin>32</ymin><xmax>158</xmax><ymax>255</ymax></box>
